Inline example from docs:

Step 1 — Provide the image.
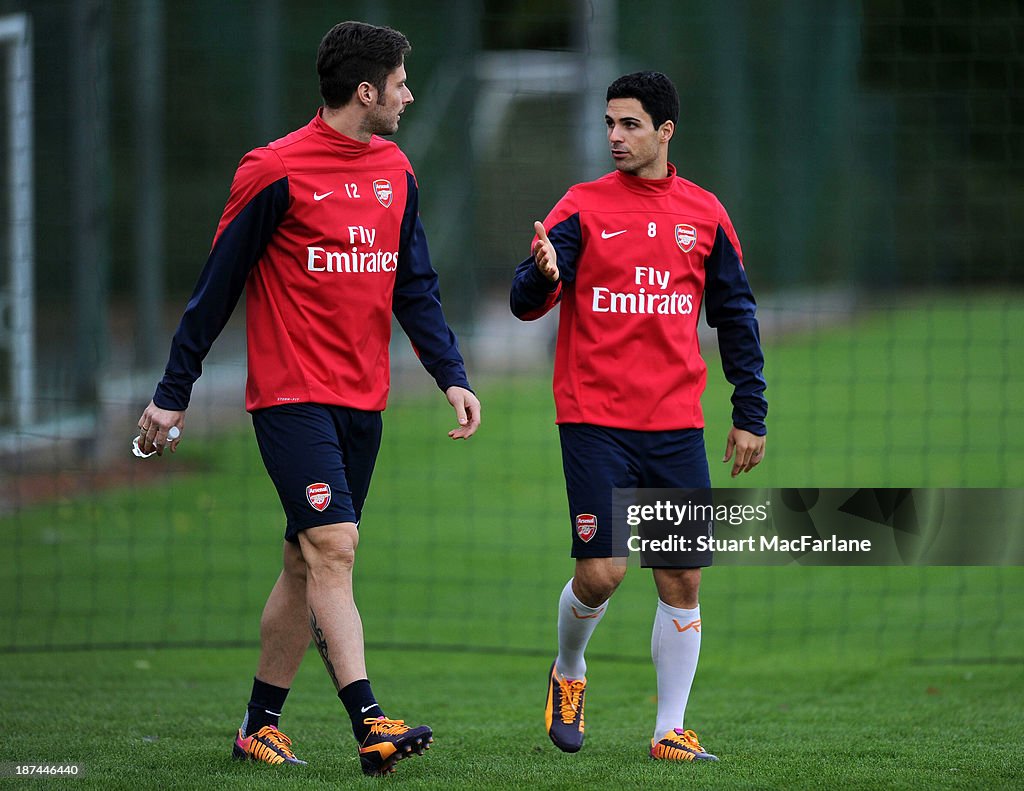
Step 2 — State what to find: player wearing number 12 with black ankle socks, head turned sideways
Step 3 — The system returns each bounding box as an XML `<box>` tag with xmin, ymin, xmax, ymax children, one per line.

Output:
<box><xmin>138</xmin><ymin>22</ymin><xmax>480</xmax><ymax>775</ymax></box>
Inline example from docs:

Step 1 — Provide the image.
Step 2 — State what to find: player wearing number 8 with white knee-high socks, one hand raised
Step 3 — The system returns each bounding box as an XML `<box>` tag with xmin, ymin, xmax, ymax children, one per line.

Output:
<box><xmin>511</xmin><ymin>72</ymin><xmax>767</xmax><ymax>761</ymax></box>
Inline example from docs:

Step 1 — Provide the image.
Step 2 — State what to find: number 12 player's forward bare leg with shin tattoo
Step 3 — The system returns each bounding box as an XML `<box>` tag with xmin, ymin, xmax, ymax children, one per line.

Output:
<box><xmin>299</xmin><ymin>522</ymin><xmax>367</xmax><ymax>691</ymax></box>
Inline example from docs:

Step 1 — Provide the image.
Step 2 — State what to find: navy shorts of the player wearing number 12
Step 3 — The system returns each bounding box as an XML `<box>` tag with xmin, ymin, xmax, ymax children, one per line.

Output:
<box><xmin>253</xmin><ymin>404</ymin><xmax>382</xmax><ymax>543</ymax></box>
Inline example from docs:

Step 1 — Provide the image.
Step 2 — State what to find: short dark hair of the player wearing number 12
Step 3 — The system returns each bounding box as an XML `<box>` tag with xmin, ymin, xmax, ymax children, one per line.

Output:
<box><xmin>316</xmin><ymin>22</ymin><xmax>413</xmax><ymax>108</ymax></box>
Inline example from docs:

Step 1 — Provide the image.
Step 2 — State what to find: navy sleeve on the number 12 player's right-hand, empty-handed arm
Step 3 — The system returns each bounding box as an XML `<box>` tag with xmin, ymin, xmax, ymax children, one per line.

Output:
<box><xmin>392</xmin><ymin>173</ymin><xmax>470</xmax><ymax>390</ymax></box>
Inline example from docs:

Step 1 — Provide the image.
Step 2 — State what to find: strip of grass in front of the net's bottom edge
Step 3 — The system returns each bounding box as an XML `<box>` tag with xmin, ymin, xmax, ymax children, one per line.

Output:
<box><xmin>0</xmin><ymin>647</ymin><xmax>1024</xmax><ymax>789</ymax></box>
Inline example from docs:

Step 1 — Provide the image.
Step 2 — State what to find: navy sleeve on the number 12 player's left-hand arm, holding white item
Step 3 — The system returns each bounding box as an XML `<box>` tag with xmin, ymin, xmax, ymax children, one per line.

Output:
<box><xmin>153</xmin><ymin>177</ymin><xmax>289</xmax><ymax>410</ymax></box>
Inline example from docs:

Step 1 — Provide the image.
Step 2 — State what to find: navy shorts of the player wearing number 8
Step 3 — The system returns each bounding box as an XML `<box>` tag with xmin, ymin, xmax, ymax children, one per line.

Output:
<box><xmin>558</xmin><ymin>423</ymin><xmax>711</xmax><ymax>557</ymax></box>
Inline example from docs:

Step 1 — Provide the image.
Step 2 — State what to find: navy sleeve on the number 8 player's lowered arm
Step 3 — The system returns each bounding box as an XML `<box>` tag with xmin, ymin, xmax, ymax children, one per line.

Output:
<box><xmin>705</xmin><ymin>225</ymin><xmax>768</xmax><ymax>436</ymax></box>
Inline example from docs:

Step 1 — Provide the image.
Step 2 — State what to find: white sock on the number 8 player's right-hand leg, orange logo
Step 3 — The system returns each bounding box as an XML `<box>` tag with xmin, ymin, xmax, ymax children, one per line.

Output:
<box><xmin>650</xmin><ymin>599</ymin><xmax>700</xmax><ymax>739</ymax></box>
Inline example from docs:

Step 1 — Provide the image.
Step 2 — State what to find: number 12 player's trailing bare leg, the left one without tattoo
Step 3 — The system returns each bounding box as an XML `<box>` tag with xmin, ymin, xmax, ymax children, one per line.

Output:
<box><xmin>256</xmin><ymin>541</ymin><xmax>309</xmax><ymax>689</ymax></box>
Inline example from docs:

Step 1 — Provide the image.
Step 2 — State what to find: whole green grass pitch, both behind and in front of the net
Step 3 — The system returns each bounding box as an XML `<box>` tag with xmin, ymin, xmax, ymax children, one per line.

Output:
<box><xmin>0</xmin><ymin>297</ymin><xmax>1024</xmax><ymax>789</ymax></box>
